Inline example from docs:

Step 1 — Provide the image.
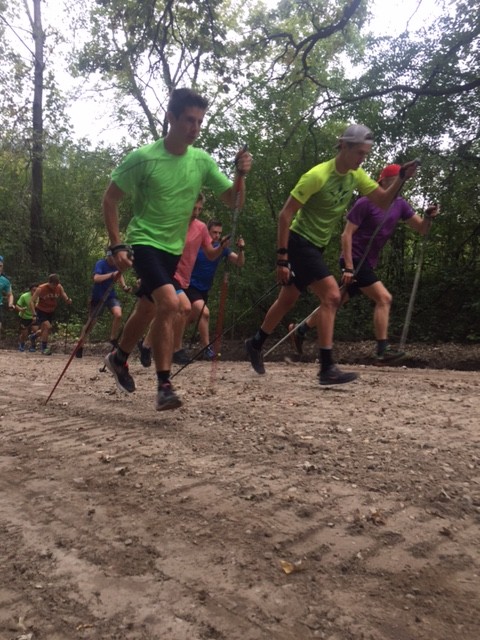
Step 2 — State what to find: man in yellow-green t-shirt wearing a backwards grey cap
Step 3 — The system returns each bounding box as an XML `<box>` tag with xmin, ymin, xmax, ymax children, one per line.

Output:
<box><xmin>245</xmin><ymin>124</ymin><xmax>416</xmax><ymax>385</ymax></box>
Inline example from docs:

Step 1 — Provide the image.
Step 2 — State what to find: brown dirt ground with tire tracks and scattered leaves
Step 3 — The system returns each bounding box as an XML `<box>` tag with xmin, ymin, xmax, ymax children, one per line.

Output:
<box><xmin>0</xmin><ymin>350</ymin><xmax>480</xmax><ymax>640</ymax></box>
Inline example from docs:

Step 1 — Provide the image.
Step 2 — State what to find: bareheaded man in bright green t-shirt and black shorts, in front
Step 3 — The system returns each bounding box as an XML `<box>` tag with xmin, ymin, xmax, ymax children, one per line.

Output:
<box><xmin>103</xmin><ymin>89</ymin><xmax>252</xmax><ymax>411</ymax></box>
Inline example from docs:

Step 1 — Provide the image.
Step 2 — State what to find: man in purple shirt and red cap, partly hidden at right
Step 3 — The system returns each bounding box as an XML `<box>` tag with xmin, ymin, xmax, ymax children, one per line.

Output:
<box><xmin>289</xmin><ymin>164</ymin><xmax>438</xmax><ymax>364</ymax></box>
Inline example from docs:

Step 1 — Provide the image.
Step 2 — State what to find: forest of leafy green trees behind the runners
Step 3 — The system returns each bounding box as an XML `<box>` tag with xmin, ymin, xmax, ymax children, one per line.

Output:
<box><xmin>0</xmin><ymin>0</ymin><xmax>480</xmax><ymax>342</ymax></box>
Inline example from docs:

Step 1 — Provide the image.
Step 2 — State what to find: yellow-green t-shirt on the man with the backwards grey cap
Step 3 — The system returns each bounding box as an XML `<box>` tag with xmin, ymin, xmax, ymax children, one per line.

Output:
<box><xmin>290</xmin><ymin>158</ymin><xmax>378</xmax><ymax>248</ymax></box>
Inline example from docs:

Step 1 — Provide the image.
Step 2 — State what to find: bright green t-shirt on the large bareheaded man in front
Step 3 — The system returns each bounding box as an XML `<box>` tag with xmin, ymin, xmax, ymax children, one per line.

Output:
<box><xmin>112</xmin><ymin>139</ymin><xmax>232</xmax><ymax>255</ymax></box>
